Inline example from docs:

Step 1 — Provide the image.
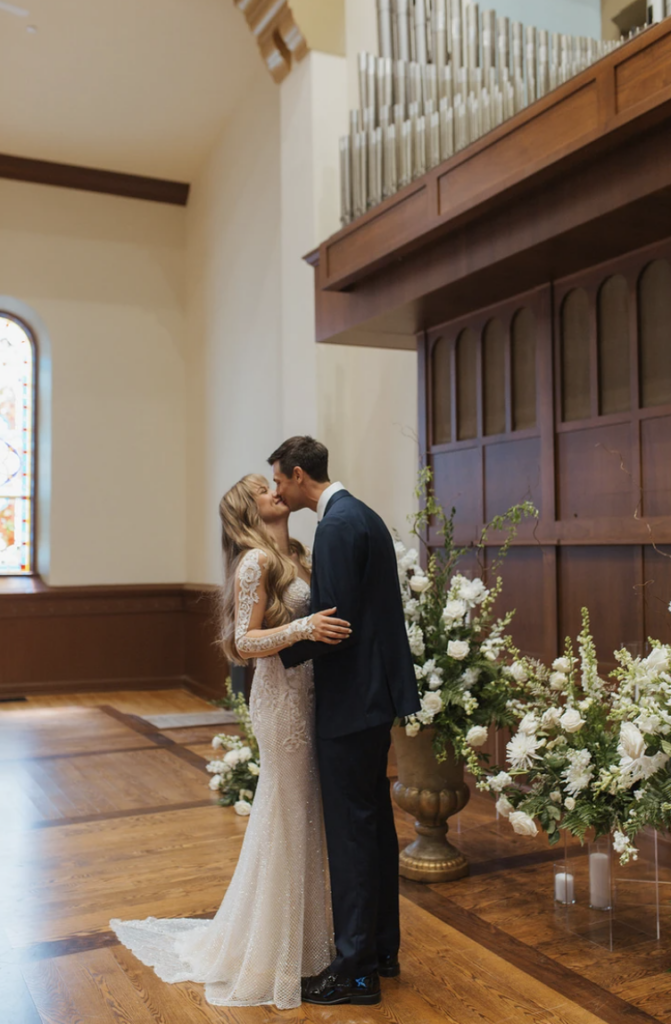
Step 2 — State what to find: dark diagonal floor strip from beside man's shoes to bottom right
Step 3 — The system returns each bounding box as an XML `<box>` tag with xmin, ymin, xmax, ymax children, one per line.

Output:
<box><xmin>400</xmin><ymin>879</ymin><xmax>659</xmax><ymax>1024</ymax></box>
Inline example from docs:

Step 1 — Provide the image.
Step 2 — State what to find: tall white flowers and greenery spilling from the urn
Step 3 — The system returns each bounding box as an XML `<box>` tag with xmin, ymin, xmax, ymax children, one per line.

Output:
<box><xmin>395</xmin><ymin>468</ymin><xmax>538</xmax><ymax>776</ymax></box>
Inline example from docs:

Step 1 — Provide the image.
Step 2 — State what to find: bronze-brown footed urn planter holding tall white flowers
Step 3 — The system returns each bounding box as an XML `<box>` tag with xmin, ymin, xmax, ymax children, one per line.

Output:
<box><xmin>392</xmin><ymin>726</ymin><xmax>470</xmax><ymax>882</ymax></box>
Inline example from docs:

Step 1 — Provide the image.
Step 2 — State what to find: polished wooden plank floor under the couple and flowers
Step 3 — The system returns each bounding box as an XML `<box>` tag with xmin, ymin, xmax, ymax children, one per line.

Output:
<box><xmin>0</xmin><ymin>690</ymin><xmax>671</xmax><ymax>1024</ymax></box>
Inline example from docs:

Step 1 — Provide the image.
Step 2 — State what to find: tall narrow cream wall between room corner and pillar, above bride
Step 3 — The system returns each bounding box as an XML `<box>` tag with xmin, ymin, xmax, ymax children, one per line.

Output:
<box><xmin>186</xmin><ymin>60</ymin><xmax>283</xmax><ymax>584</ymax></box>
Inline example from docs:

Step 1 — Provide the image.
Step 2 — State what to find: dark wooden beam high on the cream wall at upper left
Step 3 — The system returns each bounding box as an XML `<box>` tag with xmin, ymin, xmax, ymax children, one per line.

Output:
<box><xmin>0</xmin><ymin>153</ymin><xmax>190</xmax><ymax>206</ymax></box>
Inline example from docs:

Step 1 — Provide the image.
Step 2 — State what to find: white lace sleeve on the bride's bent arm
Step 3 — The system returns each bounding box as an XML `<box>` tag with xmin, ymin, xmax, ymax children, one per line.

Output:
<box><xmin>236</xmin><ymin>550</ymin><xmax>314</xmax><ymax>657</ymax></box>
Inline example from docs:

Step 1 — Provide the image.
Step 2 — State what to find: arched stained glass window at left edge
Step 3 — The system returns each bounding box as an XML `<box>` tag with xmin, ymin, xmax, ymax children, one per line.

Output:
<box><xmin>0</xmin><ymin>313</ymin><xmax>35</xmax><ymax>575</ymax></box>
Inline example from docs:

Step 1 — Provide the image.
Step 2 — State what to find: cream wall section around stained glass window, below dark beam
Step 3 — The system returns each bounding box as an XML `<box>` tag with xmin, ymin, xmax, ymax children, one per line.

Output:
<box><xmin>0</xmin><ymin>181</ymin><xmax>186</xmax><ymax>585</ymax></box>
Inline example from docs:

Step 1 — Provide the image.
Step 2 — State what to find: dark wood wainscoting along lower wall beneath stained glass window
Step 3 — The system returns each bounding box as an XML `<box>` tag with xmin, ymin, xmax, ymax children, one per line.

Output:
<box><xmin>0</xmin><ymin>580</ymin><xmax>228</xmax><ymax>699</ymax></box>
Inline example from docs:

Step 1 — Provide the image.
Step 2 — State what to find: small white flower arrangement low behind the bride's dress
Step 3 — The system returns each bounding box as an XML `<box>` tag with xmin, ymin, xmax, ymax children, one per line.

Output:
<box><xmin>207</xmin><ymin>679</ymin><xmax>259</xmax><ymax>817</ymax></box>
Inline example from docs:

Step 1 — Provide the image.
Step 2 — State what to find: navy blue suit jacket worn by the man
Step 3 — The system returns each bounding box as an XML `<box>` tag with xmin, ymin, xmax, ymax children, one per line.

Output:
<box><xmin>280</xmin><ymin>490</ymin><xmax>420</xmax><ymax>738</ymax></box>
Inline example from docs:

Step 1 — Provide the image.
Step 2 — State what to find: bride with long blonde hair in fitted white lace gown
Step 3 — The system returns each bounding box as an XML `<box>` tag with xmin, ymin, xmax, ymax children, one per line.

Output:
<box><xmin>111</xmin><ymin>475</ymin><xmax>351</xmax><ymax>1010</ymax></box>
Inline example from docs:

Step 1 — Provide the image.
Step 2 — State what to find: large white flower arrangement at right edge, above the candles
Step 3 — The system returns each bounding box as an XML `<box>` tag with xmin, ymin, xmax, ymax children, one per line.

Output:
<box><xmin>478</xmin><ymin>609</ymin><xmax>671</xmax><ymax>863</ymax></box>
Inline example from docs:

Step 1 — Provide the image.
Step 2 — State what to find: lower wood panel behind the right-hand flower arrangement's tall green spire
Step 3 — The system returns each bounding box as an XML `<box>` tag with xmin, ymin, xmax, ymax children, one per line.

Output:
<box><xmin>558</xmin><ymin>545</ymin><xmax>642</xmax><ymax>665</ymax></box>
